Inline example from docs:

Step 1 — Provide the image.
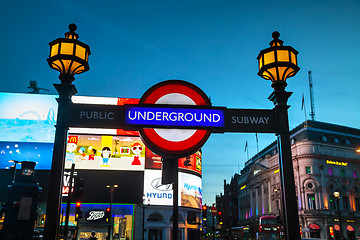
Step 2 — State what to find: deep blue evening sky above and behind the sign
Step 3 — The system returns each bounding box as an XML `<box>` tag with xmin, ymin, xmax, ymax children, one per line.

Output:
<box><xmin>0</xmin><ymin>0</ymin><xmax>360</xmax><ymax>204</ymax></box>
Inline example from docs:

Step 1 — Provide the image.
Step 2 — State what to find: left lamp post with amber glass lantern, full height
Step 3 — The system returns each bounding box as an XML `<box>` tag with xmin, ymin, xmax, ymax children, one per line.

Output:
<box><xmin>44</xmin><ymin>24</ymin><xmax>90</xmax><ymax>240</ymax></box>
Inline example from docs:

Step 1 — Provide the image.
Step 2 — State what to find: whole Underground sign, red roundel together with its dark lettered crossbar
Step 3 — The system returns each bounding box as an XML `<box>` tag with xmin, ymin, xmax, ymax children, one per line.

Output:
<box><xmin>69</xmin><ymin>80</ymin><xmax>278</xmax><ymax>157</ymax></box>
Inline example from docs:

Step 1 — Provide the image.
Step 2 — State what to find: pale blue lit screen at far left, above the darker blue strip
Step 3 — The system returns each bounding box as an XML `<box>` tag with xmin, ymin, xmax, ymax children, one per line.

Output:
<box><xmin>0</xmin><ymin>93</ymin><xmax>57</xmax><ymax>143</ymax></box>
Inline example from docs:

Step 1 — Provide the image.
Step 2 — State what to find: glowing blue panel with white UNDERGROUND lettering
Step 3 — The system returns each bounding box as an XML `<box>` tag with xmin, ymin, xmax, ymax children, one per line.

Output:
<box><xmin>125</xmin><ymin>107</ymin><xmax>225</xmax><ymax>127</ymax></box>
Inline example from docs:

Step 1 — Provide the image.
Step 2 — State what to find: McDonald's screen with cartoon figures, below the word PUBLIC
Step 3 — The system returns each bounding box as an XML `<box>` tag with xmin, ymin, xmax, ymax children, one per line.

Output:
<box><xmin>65</xmin><ymin>134</ymin><xmax>145</xmax><ymax>171</ymax></box>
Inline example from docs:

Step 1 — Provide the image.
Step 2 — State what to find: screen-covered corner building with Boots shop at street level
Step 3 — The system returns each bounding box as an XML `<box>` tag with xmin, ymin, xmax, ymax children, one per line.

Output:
<box><xmin>0</xmin><ymin>93</ymin><xmax>202</xmax><ymax>240</ymax></box>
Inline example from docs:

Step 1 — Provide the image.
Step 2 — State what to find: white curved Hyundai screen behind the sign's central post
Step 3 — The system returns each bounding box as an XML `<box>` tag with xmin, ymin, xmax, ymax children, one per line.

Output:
<box><xmin>143</xmin><ymin>169</ymin><xmax>202</xmax><ymax>209</ymax></box>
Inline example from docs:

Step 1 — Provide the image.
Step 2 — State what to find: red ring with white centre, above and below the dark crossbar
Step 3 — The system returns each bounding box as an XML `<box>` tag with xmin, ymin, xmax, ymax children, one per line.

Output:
<box><xmin>139</xmin><ymin>80</ymin><xmax>211</xmax><ymax>157</ymax></box>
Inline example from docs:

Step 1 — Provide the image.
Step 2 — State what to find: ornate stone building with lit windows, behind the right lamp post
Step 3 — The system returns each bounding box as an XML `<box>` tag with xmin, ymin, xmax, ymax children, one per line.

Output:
<box><xmin>217</xmin><ymin>120</ymin><xmax>360</xmax><ymax>239</ymax></box>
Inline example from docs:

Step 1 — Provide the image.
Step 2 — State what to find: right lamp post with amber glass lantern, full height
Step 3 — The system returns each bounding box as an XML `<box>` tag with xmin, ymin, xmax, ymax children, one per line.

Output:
<box><xmin>257</xmin><ymin>32</ymin><xmax>301</xmax><ymax>240</ymax></box>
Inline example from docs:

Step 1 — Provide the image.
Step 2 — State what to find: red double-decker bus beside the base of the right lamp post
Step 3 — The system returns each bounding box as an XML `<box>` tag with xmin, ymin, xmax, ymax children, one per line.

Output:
<box><xmin>258</xmin><ymin>215</ymin><xmax>281</xmax><ymax>240</ymax></box>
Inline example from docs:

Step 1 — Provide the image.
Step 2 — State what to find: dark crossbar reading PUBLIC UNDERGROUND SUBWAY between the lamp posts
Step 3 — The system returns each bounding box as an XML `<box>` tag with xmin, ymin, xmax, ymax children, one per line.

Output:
<box><xmin>69</xmin><ymin>103</ymin><xmax>278</xmax><ymax>133</ymax></box>
